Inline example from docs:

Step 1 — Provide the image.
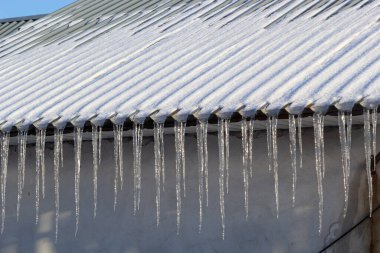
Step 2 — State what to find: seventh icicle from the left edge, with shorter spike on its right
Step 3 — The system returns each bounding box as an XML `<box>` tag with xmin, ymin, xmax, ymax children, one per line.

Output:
<box><xmin>113</xmin><ymin>124</ymin><xmax>123</xmax><ymax>210</ymax></box>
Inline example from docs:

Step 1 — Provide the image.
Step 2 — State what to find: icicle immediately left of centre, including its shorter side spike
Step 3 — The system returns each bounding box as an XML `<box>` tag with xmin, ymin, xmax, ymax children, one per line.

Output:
<box><xmin>174</xmin><ymin>121</ymin><xmax>185</xmax><ymax>234</ymax></box>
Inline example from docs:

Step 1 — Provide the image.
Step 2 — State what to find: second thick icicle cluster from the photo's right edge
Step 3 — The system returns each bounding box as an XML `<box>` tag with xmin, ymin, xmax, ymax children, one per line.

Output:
<box><xmin>338</xmin><ymin>112</ymin><xmax>352</xmax><ymax>217</ymax></box>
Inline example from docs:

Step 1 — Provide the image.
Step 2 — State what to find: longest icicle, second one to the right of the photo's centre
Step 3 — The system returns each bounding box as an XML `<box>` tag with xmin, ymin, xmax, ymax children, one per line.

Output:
<box><xmin>218</xmin><ymin>119</ymin><xmax>226</xmax><ymax>240</ymax></box>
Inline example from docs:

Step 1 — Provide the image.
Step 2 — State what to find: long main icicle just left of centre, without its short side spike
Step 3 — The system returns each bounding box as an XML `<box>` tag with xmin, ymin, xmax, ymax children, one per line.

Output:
<box><xmin>174</xmin><ymin>122</ymin><xmax>183</xmax><ymax>234</ymax></box>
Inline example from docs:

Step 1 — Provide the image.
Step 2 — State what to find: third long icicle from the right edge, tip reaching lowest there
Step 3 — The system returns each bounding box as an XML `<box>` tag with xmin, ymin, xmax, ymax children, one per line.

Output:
<box><xmin>313</xmin><ymin>113</ymin><xmax>324</xmax><ymax>234</ymax></box>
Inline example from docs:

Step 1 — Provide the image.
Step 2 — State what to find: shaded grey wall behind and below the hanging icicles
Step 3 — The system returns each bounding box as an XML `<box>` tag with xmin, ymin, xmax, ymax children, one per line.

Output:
<box><xmin>0</xmin><ymin>127</ymin><xmax>378</xmax><ymax>253</ymax></box>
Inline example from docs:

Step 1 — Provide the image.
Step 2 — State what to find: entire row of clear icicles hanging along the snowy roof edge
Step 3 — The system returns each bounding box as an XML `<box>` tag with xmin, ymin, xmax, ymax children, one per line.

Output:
<box><xmin>1</xmin><ymin>109</ymin><xmax>377</xmax><ymax>239</ymax></box>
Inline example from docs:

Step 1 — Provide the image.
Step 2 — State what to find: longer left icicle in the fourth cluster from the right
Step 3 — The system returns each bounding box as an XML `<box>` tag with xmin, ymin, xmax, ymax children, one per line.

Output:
<box><xmin>289</xmin><ymin>115</ymin><xmax>297</xmax><ymax>207</ymax></box>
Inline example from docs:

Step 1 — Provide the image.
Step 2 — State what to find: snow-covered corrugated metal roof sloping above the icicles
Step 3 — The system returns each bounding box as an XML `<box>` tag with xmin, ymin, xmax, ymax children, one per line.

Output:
<box><xmin>0</xmin><ymin>0</ymin><xmax>380</xmax><ymax>129</ymax></box>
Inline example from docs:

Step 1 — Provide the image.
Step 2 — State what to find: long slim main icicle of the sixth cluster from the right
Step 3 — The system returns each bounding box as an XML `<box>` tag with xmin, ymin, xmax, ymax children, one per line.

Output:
<box><xmin>241</xmin><ymin>118</ymin><xmax>249</xmax><ymax>220</ymax></box>
